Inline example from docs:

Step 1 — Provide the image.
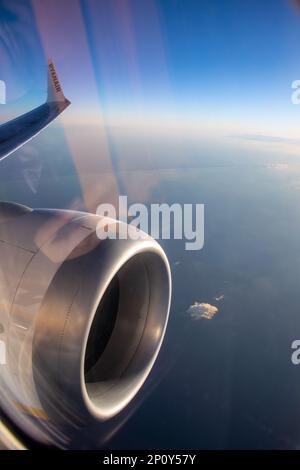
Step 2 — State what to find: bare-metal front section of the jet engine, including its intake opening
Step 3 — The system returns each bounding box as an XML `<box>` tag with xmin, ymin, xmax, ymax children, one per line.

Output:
<box><xmin>32</xmin><ymin>220</ymin><xmax>171</xmax><ymax>427</ymax></box>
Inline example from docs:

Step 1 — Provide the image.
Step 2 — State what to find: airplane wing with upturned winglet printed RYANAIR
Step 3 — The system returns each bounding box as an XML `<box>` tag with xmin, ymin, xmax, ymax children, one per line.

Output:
<box><xmin>0</xmin><ymin>60</ymin><xmax>71</xmax><ymax>161</ymax></box>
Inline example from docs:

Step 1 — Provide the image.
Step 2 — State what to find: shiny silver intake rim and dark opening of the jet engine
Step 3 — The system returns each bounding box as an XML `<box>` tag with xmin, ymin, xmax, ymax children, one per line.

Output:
<box><xmin>80</xmin><ymin>238</ymin><xmax>171</xmax><ymax>420</ymax></box>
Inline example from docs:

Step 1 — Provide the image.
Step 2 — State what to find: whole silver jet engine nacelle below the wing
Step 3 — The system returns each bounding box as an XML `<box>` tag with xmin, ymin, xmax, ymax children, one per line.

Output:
<box><xmin>0</xmin><ymin>203</ymin><xmax>171</xmax><ymax>447</ymax></box>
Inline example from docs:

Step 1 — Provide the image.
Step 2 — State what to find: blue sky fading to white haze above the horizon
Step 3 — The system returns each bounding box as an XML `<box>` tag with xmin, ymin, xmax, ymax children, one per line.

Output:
<box><xmin>0</xmin><ymin>0</ymin><xmax>300</xmax><ymax>137</ymax></box>
